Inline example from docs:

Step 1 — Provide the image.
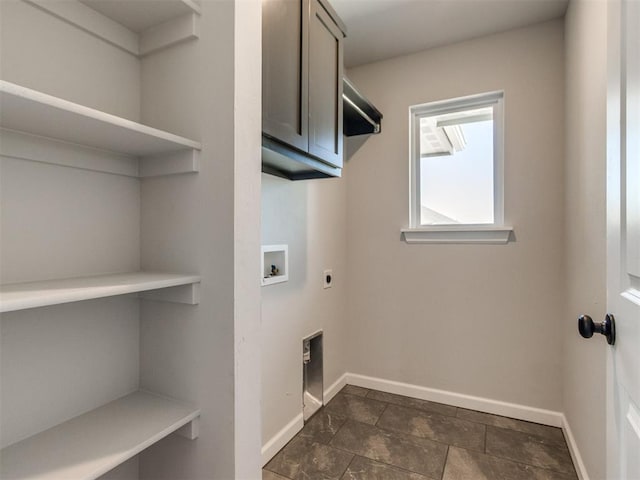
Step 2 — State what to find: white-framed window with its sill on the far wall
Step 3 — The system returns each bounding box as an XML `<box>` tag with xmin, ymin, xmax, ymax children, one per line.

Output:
<box><xmin>404</xmin><ymin>92</ymin><xmax>511</xmax><ymax>243</ymax></box>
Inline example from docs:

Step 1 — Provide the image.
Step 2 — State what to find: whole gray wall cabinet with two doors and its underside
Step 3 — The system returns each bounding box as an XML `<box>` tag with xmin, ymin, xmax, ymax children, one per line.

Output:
<box><xmin>262</xmin><ymin>0</ymin><xmax>346</xmax><ymax>180</ymax></box>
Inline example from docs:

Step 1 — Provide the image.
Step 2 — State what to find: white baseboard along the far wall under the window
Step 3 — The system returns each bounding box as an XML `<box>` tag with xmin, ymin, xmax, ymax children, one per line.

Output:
<box><xmin>346</xmin><ymin>373</ymin><xmax>563</xmax><ymax>427</ymax></box>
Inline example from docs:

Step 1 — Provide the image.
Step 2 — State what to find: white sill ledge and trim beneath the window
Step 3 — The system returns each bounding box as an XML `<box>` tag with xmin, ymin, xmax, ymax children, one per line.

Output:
<box><xmin>401</xmin><ymin>225</ymin><xmax>513</xmax><ymax>244</ymax></box>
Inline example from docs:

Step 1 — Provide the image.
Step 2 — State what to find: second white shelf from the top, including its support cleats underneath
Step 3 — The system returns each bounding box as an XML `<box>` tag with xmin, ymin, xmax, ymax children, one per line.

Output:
<box><xmin>0</xmin><ymin>80</ymin><xmax>202</xmax><ymax>177</ymax></box>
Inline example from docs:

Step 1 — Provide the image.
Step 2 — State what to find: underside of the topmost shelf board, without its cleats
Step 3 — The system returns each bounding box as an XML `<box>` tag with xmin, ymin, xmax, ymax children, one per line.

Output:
<box><xmin>80</xmin><ymin>0</ymin><xmax>200</xmax><ymax>33</ymax></box>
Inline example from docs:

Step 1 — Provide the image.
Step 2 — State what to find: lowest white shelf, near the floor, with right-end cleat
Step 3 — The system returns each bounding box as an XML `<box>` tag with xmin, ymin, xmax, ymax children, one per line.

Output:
<box><xmin>0</xmin><ymin>391</ymin><xmax>200</xmax><ymax>480</ymax></box>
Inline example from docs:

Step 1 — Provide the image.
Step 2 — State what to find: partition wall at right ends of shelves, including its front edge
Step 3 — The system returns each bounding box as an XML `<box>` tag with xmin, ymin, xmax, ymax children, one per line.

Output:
<box><xmin>140</xmin><ymin>0</ymin><xmax>261</xmax><ymax>480</ymax></box>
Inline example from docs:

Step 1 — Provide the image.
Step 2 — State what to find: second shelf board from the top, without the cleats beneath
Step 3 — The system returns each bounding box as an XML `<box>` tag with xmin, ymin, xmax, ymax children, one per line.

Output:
<box><xmin>0</xmin><ymin>80</ymin><xmax>202</xmax><ymax>157</ymax></box>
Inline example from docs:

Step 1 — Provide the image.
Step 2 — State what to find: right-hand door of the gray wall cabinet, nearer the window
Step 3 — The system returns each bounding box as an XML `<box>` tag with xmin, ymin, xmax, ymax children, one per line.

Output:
<box><xmin>309</xmin><ymin>0</ymin><xmax>343</xmax><ymax>168</ymax></box>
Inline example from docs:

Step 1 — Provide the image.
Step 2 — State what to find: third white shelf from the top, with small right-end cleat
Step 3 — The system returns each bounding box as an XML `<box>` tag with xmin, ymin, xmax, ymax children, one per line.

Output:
<box><xmin>0</xmin><ymin>272</ymin><xmax>200</xmax><ymax>312</ymax></box>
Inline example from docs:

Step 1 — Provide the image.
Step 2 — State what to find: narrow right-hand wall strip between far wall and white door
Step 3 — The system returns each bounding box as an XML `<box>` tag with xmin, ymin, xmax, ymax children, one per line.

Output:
<box><xmin>562</xmin><ymin>0</ymin><xmax>608</xmax><ymax>480</ymax></box>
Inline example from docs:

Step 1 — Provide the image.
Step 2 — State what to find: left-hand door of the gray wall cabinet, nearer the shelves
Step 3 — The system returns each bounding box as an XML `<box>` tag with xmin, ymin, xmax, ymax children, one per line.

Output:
<box><xmin>262</xmin><ymin>0</ymin><xmax>309</xmax><ymax>152</ymax></box>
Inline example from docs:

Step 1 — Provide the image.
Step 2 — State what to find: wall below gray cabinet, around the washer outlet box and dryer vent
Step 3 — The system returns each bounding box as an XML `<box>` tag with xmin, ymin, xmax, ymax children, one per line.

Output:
<box><xmin>256</xmin><ymin>174</ymin><xmax>349</xmax><ymax>444</ymax></box>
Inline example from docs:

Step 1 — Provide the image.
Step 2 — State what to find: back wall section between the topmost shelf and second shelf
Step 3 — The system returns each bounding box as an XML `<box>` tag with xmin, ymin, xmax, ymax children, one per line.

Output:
<box><xmin>0</xmin><ymin>0</ymin><xmax>140</xmax><ymax>121</ymax></box>
